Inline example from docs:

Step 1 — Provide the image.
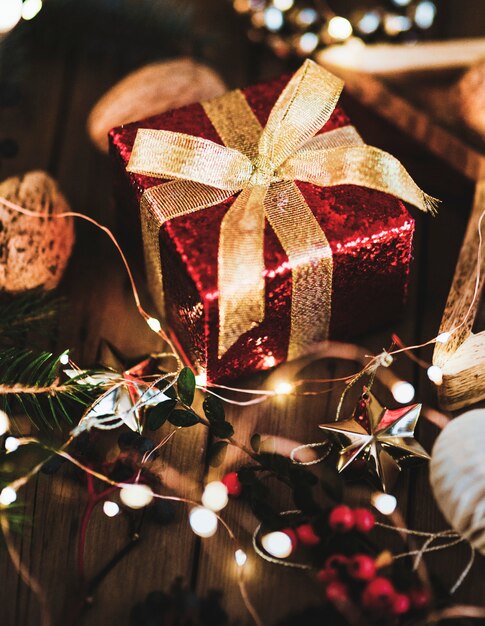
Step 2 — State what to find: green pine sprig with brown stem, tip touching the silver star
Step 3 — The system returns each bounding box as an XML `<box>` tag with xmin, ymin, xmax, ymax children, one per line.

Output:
<box><xmin>0</xmin><ymin>348</ymin><xmax>99</xmax><ymax>429</ymax></box>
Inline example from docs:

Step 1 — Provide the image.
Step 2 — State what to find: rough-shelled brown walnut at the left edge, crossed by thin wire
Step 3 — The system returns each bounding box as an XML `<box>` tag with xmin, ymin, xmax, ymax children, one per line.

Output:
<box><xmin>0</xmin><ymin>171</ymin><xmax>74</xmax><ymax>293</ymax></box>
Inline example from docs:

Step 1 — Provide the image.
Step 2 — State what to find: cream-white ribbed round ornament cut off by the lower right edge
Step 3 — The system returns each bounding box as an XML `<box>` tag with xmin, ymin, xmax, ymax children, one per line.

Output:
<box><xmin>430</xmin><ymin>409</ymin><xmax>485</xmax><ymax>555</ymax></box>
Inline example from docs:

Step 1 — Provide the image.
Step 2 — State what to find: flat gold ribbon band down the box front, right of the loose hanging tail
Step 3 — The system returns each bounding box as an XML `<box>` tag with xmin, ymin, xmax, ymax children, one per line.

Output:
<box><xmin>264</xmin><ymin>181</ymin><xmax>333</xmax><ymax>360</ymax></box>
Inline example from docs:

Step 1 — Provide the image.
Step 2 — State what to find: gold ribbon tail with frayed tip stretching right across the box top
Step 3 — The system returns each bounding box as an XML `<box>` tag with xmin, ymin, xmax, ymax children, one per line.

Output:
<box><xmin>281</xmin><ymin>145</ymin><xmax>439</xmax><ymax>215</ymax></box>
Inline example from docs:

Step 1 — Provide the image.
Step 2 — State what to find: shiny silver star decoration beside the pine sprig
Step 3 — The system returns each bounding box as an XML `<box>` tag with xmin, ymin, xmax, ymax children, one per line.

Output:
<box><xmin>64</xmin><ymin>341</ymin><xmax>173</xmax><ymax>435</ymax></box>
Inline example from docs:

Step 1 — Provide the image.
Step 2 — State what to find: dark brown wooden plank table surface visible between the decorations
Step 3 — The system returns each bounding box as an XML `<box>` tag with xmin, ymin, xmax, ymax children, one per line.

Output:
<box><xmin>0</xmin><ymin>0</ymin><xmax>485</xmax><ymax>626</ymax></box>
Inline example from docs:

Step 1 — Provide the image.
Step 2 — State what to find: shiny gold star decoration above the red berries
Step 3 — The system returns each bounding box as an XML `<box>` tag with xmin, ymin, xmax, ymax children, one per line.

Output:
<box><xmin>319</xmin><ymin>391</ymin><xmax>430</xmax><ymax>491</ymax></box>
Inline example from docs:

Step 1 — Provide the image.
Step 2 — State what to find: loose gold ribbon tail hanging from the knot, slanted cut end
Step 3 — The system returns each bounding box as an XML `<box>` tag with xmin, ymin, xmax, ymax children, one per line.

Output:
<box><xmin>218</xmin><ymin>186</ymin><xmax>267</xmax><ymax>358</ymax></box>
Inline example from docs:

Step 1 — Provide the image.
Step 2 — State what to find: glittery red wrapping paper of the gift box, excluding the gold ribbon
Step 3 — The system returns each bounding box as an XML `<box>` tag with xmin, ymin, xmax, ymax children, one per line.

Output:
<box><xmin>110</xmin><ymin>77</ymin><xmax>414</xmax><ymax>382</ymax></box>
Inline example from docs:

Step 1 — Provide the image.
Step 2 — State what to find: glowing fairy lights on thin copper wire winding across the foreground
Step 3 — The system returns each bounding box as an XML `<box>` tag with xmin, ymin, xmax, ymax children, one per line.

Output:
<box><xmin>0</xmin><ymin>198</ymin><xmax>485</xmax><ymax>625</ymax></box>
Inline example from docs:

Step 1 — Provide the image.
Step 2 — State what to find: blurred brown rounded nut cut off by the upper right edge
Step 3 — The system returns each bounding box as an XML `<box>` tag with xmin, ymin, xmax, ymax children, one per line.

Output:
<box><xmin>457</xmin><ymin>60</ymin><xmax>485</xmax><ymax>139</ymax></box>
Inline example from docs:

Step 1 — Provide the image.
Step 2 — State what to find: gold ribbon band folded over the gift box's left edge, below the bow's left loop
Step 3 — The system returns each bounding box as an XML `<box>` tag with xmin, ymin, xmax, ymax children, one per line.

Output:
<box><xmin>140</xmin><ymin>181</ymin><xmax>232</xmax><ymax>320</ymax></box>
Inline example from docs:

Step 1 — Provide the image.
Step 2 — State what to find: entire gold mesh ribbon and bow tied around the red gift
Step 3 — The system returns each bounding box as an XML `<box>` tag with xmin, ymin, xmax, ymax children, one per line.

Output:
<box><xmin>127</xmin><ymin>61</ymin><xmax>435</xmax><ymax>359</ymax></box>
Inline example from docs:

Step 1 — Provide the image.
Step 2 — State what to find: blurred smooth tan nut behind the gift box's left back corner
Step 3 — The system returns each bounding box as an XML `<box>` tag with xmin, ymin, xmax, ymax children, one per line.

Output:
<box><xmin>87</xmin><ymin>58</ymin><xmax>227</xmax><ymax>152</ymax></box>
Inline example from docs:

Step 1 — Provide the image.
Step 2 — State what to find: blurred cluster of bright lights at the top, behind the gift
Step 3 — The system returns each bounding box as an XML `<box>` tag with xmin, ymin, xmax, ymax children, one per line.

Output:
<box><xmin>232</xmin><ymin>0</ymin><xmax>437</xmax><ymax>58</ymax></box>
